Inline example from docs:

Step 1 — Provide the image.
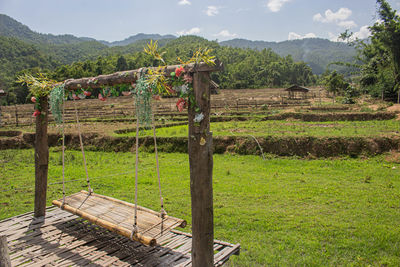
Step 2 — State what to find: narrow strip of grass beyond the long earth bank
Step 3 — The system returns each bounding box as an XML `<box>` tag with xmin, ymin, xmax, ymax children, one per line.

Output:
<box><xmin>119</xmin><ymin>120</ymin><xmax>400</xmax><ymax>137</ymax></box>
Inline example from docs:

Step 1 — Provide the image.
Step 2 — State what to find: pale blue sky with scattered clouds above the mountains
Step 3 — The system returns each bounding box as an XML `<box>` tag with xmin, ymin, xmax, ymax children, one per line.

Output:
<box><xmin>0</xmin><ymin>0</ymin><xmax>400</xmax><ymax>41</ymax></box>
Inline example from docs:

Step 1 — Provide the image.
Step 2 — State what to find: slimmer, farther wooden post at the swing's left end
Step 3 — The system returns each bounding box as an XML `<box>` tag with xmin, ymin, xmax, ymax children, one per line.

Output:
<box><xmin>34</xmin><ymin>97</ymin><xmax>49</xmax><ymax>217</ymax></box>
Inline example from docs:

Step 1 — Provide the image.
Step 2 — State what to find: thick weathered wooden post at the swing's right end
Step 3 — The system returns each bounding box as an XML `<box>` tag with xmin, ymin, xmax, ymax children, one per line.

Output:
<box><xmin>189</xmin><ymin>72</ymin><xmax>214</xmax><ymax>267</ymax></box>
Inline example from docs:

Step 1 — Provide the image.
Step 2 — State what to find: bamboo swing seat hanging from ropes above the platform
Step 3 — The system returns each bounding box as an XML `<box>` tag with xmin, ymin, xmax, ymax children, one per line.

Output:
<box><xmin>53</xmin><ymin>191</ymin><xmax>186</xmax><ymax>246</ymax></box>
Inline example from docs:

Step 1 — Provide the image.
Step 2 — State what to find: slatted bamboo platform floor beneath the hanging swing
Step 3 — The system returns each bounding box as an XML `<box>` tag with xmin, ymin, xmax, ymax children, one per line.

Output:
<box><xmin>0</xmin><ymin>206</ymin><xmax>240</xmax><ymax>267</ymax></box>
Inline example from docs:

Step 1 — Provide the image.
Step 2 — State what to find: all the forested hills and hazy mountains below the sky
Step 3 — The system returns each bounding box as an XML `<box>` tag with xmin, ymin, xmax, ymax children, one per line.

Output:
<box><xmin>0</xmin><ymin>15</ymin><xmax>354</xmax><ymax>103</ymax></box>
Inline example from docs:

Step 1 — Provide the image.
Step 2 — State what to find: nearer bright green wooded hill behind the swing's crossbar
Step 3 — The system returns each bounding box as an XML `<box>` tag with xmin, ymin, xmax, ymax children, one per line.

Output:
<box><xmin>53</xmin><ymin>36</ymin><xmax>316</xmax><ymax>89</ymax></box>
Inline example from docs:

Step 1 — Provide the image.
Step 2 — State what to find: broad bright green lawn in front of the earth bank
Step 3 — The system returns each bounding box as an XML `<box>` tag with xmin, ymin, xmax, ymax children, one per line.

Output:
<box><xmin>0</xmin><ymin>149</ymin><xmax>400</xmax><ymax>266</ymax></box>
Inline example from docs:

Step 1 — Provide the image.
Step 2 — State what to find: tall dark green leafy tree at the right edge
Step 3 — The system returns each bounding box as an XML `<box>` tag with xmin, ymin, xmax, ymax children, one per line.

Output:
<box><xmin>342</xmin><ymin>0</ymin><xmax>400</xmax><ymax>100</ymax></box>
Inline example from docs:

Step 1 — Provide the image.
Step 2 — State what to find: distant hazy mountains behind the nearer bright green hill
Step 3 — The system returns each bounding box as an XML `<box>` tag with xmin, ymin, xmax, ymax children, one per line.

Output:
<box><xmin>0</xmin><ymin>14</ymin><xmax>356</xmax><ymax>74</ymax></box>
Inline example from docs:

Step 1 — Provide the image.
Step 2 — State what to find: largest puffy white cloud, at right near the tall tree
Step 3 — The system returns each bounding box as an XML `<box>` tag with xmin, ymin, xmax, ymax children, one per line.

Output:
<box><xmin>313</xmin><ymin>7</ymin><xmax>357</xmax><ymax>28</ymax></box>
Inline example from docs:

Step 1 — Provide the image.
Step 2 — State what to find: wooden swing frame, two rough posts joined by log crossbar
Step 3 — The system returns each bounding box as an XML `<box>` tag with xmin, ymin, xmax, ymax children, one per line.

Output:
<box><xmin>34</xmin><ymin>61</ymin><xmax>223</xmax><ymax>266</ymax></box>
